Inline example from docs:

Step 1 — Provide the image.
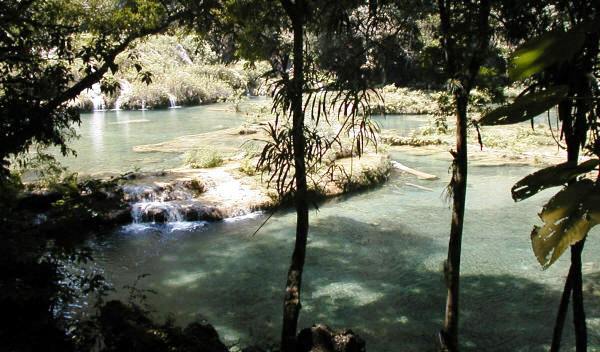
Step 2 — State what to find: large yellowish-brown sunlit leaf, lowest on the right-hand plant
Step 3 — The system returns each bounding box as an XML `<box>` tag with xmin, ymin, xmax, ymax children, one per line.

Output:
<box><xmin>531</xmin><ymin>179</ymin><xmax>600</xmax><ymax>269</ymax></box>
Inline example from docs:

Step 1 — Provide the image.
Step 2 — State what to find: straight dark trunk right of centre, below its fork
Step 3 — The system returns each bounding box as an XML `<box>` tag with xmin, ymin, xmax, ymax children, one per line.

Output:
<box><xmin>441</xmin><ymin>92</ymin><xmax>468</xmax><ymax>352</ymax></box>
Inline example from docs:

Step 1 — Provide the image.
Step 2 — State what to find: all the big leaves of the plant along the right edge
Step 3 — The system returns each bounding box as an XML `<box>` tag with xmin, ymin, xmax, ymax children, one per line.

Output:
<box><xmin>478</xmin><ymin>11</ymin><xmax>598</xmax><ymax>267</ymax></box>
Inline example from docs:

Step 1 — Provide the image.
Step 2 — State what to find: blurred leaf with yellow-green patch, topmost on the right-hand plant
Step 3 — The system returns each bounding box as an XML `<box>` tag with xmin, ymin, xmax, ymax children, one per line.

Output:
<box><xmin>508</xmin><ymin>26</ymin><xmax>585</xmax><ymax>81</ymax></box>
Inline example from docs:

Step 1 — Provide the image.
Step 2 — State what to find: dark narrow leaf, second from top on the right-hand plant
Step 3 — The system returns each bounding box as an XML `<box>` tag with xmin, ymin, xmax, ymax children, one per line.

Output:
<box><xmin>478</xmin><ymin>86</ymin><xmax>569</xmax><ymax>126</ymax></box>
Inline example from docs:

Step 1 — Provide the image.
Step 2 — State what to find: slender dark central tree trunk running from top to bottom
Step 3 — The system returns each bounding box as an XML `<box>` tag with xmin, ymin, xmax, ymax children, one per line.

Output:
<box><xmin>281</xmin><ymin>0</ymin><xmax>308</xmax><ymax>352</ymax></box>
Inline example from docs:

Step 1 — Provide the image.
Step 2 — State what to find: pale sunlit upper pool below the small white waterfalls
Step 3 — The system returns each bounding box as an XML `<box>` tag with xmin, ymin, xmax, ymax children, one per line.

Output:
<box><xmin>60</xmin><ymin>104</ymin><xmax>244</xmax><ymax>174</ymax></box>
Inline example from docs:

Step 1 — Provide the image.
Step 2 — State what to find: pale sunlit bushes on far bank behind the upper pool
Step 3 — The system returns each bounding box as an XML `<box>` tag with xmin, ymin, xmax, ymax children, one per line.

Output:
<box><xmin>77</xmin><ymin>33</ymin><xmax>266</xmax><ymax>109</ymax></box>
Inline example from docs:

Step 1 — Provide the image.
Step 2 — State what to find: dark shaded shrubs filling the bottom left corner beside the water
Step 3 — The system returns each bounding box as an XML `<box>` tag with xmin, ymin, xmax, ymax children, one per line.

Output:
<box><xmin>0</xmin><ymin>167</ymin><xmax>129</xmax><ymax>351</ymax></box>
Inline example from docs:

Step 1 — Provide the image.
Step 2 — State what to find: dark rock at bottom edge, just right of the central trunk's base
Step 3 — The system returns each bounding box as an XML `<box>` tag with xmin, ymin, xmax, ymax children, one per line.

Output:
<box><xmin>298</xmin><ymin>324</ymin><xmax>366</xmax><ymax>352</ymax></box>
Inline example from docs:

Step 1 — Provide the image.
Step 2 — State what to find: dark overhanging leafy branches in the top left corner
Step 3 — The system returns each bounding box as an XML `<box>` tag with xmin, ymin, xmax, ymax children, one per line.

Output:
<box><xmin>0</xmin><ymin>0</ymin><xmax>199</xmax><ymax>175</ymax></box>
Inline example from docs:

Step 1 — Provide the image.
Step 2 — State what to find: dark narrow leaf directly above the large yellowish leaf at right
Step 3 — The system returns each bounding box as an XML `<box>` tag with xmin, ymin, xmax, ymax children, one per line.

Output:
<box><xmin>511</xmin><ymin>159</ymin><xmax>600</xmax><ymax>202</ymax></box>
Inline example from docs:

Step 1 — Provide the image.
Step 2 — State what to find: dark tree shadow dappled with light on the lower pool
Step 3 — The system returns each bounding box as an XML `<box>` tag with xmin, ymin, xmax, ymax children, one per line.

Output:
<box><xmin>98</xmin><ymin>216</ymin><xmax>600</xmax><ymax>351</ymax></box>
